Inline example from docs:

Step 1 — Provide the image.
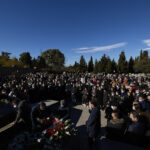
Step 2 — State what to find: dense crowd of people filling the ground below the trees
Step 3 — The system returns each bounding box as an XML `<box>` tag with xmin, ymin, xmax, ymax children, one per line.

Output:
<box><xmin>0</xmin><ymin>72</ymin><xmax>150</xmax><ymax>148</ymax></box>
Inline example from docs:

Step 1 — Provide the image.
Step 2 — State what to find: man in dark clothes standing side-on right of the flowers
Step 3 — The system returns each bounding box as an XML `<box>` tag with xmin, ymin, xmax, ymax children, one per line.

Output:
<box><xmin>86</xmin><ymin>98</ymin><xmax>100</xmax><ymax>150</ymax></box>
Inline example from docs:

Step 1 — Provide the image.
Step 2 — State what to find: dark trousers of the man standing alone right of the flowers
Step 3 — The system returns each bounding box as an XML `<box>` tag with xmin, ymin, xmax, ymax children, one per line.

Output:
<box><xmin>88</xmin><ymin>137</ymin><xmax>100</xmax><ymax>150</ymax></box>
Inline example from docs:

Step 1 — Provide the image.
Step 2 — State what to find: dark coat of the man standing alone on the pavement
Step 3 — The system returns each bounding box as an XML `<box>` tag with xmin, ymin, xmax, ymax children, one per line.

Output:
<box><xmin>86</xmin><ymin>107</ymin><xmax>100</xmax><ymax>137</ymax></box>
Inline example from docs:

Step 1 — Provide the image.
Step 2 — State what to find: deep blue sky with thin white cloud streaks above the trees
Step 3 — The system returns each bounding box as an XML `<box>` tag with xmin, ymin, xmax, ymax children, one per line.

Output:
<box><xmin>0</xmin><ymin>0</ymin><xmax>150</xmax><ymax>65</ymax></box>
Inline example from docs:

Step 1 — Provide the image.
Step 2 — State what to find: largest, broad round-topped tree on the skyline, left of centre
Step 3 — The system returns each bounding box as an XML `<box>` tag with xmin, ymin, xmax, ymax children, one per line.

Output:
<box><xmin>42</xmin><ymin>49</ymin><xmax>65</xmax><ymax>67</ymax></box>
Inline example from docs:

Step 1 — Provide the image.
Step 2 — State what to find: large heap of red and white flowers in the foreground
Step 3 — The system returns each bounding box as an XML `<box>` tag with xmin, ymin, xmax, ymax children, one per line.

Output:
<box><xmin>7</xmin><ymin>120</ymin><xmax>77</xmax><ymax>150</ymax></box>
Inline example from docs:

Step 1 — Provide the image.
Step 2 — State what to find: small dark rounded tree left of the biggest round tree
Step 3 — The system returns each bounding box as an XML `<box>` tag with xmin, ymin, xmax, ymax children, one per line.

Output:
<box><xmin>19</xmin><ymin>52</ymin><xmax>32</xmax><ymax>67</ymax></box>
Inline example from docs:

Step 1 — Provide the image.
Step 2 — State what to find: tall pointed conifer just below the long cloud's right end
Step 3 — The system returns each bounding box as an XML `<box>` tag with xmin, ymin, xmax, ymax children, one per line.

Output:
<box><xmin>118</xmin><ymin>51</ymin><xmax>127</xmax><ymax>73</ymax></box>
